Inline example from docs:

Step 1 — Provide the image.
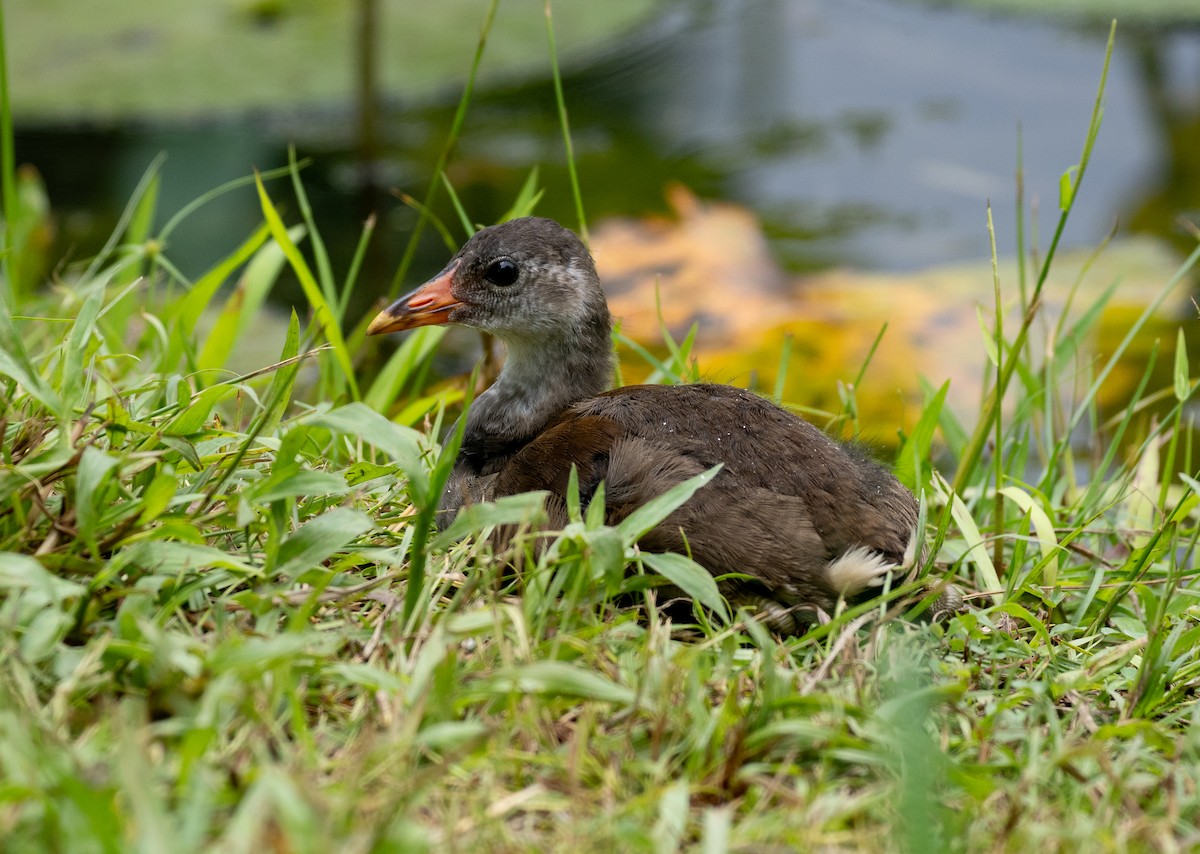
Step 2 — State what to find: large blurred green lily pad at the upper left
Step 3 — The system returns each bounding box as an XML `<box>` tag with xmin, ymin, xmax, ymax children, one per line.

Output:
<box><xmin>5</xmin><ymin>0</ymin><xmax>655</xmax><ymax>122</ymax></box>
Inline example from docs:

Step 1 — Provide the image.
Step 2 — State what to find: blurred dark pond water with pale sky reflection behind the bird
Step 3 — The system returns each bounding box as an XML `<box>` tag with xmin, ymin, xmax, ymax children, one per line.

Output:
<box><xmin>17</xmin><ymin>0</ymin><xmax>1200</xmax><ymax>307</ymax></box>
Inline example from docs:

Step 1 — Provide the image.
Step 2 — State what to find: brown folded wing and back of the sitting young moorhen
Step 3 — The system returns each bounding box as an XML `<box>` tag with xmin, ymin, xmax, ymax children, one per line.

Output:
<box><xmin>494</xmin><ymin>385</ymin><xmax>917</xmax><ymax>577</ymax></box>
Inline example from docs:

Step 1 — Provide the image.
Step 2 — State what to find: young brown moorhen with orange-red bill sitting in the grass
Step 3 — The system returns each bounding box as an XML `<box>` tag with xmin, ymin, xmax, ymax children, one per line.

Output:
<box><xmin>367</xmin><ymin>217</ymin><xmax>917</xmax><ymax>632</ymax></box>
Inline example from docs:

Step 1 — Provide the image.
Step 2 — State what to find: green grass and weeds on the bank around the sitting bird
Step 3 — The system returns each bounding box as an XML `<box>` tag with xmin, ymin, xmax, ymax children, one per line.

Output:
<box><xmin>0</xmin><ymin>13</ymin><xmax>1200</xmax><ymax>853</ymax></box>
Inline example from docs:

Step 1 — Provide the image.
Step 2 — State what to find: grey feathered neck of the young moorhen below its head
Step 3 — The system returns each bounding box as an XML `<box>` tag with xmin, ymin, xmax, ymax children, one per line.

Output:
<box><xmin>463</xmin><ymin>312</ymin><xmax>613</xmax><ymax>468</ymax></box>
